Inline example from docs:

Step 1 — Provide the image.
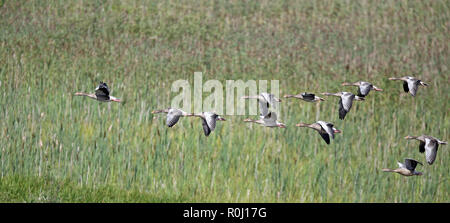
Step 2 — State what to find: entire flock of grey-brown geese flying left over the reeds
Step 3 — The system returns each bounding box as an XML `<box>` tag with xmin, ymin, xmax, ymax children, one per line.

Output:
<box><xmin>75</xmin><ymin>76</ymin><xmax>447</xmax><ymax>176</ymax></box>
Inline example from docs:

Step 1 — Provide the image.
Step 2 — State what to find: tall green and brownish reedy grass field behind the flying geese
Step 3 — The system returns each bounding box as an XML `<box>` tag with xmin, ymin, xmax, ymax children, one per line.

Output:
<box><xmin>0</xmin><ymin>0</ymin><xmax>450</xmax><ymax>202</ymax></box>
